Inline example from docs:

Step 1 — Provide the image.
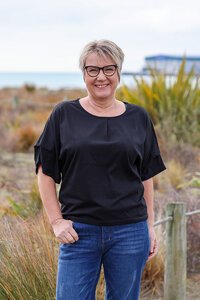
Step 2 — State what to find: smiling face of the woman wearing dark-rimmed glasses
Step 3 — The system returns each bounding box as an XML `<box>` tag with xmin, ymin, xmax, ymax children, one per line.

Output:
<box><xmin>84</xmin><ymin>53</ymin><xmax>119</xmax><ymax>100</ymax></box>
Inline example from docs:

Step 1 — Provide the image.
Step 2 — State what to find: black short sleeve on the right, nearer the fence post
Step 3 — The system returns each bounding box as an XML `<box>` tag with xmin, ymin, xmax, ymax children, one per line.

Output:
<box><xmin>141</xmin><ymin>114</ymin><xmax>166</xmax><ymax>181</ymax></box>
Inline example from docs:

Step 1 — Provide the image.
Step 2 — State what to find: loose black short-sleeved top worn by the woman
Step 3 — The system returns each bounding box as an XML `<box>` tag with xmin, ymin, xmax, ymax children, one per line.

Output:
<box><xmin>34</xmin><ymin>99</ymin><xmax>165</xmax><ymax>226</ymax></box>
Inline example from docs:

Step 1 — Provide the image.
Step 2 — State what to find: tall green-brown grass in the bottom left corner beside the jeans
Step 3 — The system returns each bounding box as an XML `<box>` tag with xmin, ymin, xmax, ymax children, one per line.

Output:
<box><xmin>0</xmin><ymin>212</ymin><xmax>58</xmax><ymax>300</ymax></box>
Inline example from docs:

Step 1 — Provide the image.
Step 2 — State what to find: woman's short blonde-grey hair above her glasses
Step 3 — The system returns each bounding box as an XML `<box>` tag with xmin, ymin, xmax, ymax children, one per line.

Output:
<box><xmin>79</xmin><ymin>40</ymin><xmax>124</xmax><ymax>73</ymax></box>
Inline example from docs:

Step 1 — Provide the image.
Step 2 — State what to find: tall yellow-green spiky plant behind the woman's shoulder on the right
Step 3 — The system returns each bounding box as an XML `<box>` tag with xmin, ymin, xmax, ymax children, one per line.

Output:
<box><xmin>118</xmin><ymin>60</ymin><xmax>200</xmax><ymax>146</ymax></box>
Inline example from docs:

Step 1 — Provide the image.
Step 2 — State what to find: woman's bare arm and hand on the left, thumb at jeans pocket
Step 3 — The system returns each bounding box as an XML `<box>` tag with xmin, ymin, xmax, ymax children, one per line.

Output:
<box><xmin>38</xmin><ymin>165</ymin><xmax>78</xmax><ymax>243</ymax></box>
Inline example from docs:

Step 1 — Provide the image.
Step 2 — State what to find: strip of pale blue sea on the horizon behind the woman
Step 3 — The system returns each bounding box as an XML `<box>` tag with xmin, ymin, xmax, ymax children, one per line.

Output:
<box><xmin>0</xmin><ymin>72</ymin><xmax>134</xmax><ymax>90</ymax></box>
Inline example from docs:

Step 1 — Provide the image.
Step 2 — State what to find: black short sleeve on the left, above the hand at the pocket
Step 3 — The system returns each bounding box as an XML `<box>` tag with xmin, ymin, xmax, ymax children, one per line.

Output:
<box><xmin>34</xmin><ymin>106</ymin><xmax>61</xmax><ymax>184</ymax></box>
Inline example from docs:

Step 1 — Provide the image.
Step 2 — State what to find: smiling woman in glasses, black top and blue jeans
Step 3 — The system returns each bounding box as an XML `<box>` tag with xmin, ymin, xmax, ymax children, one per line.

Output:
<box><xmin>35</xmin><ymin>40</ymin><xmax>165</xmax><ymax>300</ymax></box>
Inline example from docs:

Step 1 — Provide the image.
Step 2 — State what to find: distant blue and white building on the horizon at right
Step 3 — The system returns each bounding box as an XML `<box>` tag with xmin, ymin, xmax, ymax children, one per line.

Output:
<box><xmin>143</xmin><ymin>55</ymin><xmax>200</xmax><ymax>75</ymax></box>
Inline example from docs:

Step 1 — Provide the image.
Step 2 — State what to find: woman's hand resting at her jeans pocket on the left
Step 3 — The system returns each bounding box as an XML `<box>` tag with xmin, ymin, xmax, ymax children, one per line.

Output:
<box><xmin>52</xmin><ymin>218</ymin><xmax>79</xmax><ymax>244</ymax></box>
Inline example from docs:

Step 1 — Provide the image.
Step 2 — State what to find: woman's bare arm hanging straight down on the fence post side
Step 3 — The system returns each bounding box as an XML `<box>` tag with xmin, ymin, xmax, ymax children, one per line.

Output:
<box><xmin>143</xmin><ymin>178</ymin><xmax>158</xmax><ymax>260</ymax></box>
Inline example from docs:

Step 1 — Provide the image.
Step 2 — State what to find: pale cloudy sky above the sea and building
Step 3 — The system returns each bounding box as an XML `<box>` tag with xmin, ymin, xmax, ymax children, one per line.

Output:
<box><xmin>0</xmin><ymin>0</ymin><xmax>200</xmax><ymax>72</ymax></box>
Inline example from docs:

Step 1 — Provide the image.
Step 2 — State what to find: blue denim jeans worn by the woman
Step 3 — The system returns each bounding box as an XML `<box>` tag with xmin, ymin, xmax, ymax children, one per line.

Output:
<box><xmin>56</xmin><ymin>221</ymin><xmax>149</xmax><ymax>300</ymax></box>
